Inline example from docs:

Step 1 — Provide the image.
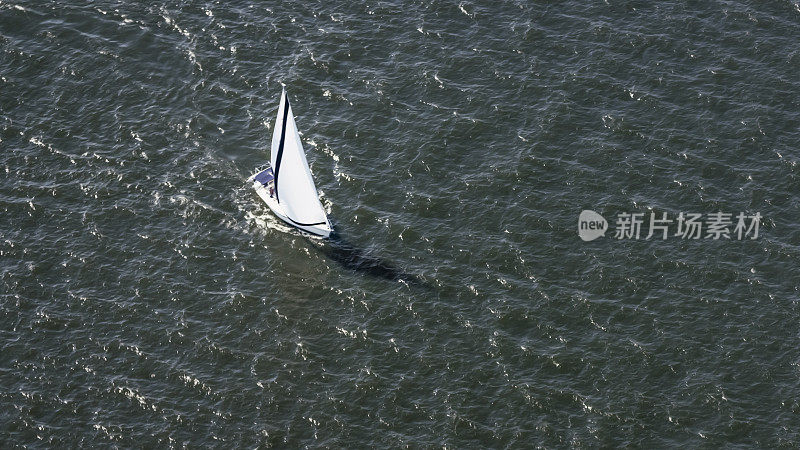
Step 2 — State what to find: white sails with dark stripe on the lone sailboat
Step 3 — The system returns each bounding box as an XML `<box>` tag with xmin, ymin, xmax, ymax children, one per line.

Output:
<box><xmin>270</xmin><ymin>90</ymin><xmax>328</xmax><ymax>226</ymax></box>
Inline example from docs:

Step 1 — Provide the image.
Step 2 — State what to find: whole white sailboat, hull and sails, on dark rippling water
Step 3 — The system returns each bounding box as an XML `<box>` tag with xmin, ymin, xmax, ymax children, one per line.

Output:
<box><xmin>248</xmin><ymin>89</ymin><xmax>332</xmax><ymax>238</ymax></box>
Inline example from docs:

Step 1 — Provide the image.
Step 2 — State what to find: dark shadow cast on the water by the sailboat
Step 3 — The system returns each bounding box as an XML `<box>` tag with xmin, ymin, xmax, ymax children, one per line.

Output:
<box><xmin>308</xmin><ymin>230</ymin><xmax>423</xmax><ymax>284</ymax></box>
